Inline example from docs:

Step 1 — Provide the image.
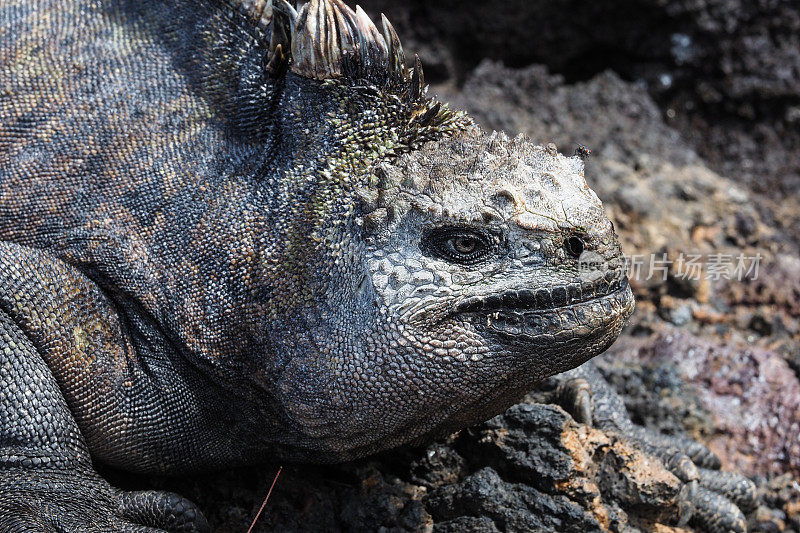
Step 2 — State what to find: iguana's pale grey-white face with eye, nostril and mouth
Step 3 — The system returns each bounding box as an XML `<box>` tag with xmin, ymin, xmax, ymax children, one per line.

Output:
<box><xmin>362</xmin><ymin>128</ymin><xmax>633</xmax><ymax>378</ymax></box>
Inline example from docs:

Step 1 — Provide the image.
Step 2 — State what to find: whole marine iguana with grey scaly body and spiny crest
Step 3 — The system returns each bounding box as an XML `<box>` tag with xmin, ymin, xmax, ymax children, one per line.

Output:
<box><xmin>0</xmin><ymin>0</ymin><xmax>756</xmax><ymax>531</ymax></box>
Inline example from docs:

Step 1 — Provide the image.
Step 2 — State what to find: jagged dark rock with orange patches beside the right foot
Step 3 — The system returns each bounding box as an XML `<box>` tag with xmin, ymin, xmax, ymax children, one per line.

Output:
<box><xmin>454</xmin><ymin>403</ymin><xmax>681</xmax><ymax>531</ymax></box>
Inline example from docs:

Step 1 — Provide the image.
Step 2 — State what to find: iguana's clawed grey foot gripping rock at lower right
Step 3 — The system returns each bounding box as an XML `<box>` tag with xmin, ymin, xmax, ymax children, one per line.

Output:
<box><xmin>555</xmin><ymin>364</ymin><xmax>757</xmax><ymax>533</ymax></box>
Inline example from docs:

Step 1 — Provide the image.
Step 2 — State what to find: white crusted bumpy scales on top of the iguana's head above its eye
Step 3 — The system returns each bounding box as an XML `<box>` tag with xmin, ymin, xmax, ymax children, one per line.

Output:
<box><xmin>358</xmin><ymin>129</ymin><xmax>605</xmax><ymax>232</ymax></box>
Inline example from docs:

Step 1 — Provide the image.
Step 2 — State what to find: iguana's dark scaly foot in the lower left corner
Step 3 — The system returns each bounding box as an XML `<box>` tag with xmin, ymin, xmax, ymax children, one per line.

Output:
<box><xmin>0</xmin><ymin>464</ymin><xmax>209</xmax><ymax>533</ymax></box>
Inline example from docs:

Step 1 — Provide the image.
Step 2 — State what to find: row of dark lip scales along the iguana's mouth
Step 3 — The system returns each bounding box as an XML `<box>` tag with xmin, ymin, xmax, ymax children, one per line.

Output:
<box><xmin>456</xmin><ymin>277</ymin><xmax>628</xmax><ymax>313</ymax></box>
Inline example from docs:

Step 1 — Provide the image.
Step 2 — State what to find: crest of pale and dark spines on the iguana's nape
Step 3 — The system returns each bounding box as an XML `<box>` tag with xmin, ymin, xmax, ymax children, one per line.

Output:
<box><xmin>227</xmin><ymin>0</ymin><xmax>472</xmax><ymax>154</ymax></box>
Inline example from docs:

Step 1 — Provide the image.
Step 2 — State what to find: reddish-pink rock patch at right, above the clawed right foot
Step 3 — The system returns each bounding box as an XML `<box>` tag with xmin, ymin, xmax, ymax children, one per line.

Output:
<box><xmin>612</xmin><ymin>330</ymin><xmax>800</xmax><ymax>476</ymax></box>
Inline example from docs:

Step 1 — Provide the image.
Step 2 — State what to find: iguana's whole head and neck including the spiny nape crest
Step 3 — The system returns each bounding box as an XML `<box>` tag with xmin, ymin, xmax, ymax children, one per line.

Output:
<box><xmin>188</xmin><ymin>0</ymin><xmax>633</xmax><ymax>461</ymax></box>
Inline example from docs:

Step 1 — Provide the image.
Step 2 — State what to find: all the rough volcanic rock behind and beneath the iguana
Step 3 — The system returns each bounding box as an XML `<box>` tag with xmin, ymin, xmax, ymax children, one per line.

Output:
<box><xmin>115</xmin><ymin>0</ymin><xmax>800</xmax><ymax>533</ymax></box>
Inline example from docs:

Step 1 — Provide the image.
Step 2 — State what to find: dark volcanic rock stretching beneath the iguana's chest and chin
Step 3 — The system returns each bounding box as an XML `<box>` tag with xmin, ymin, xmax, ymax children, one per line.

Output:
<box><xmin>144</xmin><ymin>403</ymin><xmax>682</xmax><ymax>533</ymax></box>
